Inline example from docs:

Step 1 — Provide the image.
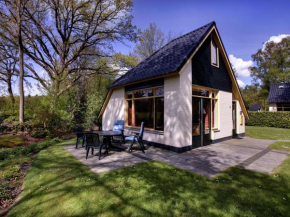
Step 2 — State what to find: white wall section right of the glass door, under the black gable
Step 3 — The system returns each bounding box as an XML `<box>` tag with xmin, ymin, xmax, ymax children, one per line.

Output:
<box><xmin>212</xmin><ymin>90</ymin><xmax>233</xmax><ymax>140</ymax></box>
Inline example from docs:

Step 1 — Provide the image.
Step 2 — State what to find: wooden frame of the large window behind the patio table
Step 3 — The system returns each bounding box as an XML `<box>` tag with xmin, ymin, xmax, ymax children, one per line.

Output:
<box><xmin>125</xmin><ymin>85</ymin><xmax>165</xmax><ymax>133</ymax></box>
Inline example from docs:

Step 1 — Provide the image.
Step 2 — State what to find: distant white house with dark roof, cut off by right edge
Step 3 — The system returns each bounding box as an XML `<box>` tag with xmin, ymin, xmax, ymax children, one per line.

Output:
<box><xmin>267</xmin><ymin>83</ymin><xmax>290</xmax><ymax>111</ymax></box>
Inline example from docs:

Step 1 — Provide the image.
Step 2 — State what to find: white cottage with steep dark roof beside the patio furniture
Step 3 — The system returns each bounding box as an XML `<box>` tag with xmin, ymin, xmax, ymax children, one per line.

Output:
<box><xmin>99</xmin><ymin>22</ymin><xmax>248</xmax><ymax>152</ymax></box>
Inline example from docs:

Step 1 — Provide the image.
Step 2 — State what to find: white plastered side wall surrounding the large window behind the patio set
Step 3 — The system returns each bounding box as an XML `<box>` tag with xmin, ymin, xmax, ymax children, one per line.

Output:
<box><xmin>103</xmin><ymin>62</ymin><xmax>192</xmax><ymax>148</ymax></box>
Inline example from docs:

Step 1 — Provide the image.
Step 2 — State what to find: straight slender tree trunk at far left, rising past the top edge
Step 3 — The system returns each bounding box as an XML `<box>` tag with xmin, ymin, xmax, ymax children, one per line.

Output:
<box><xmin>17</xmin><ymin>0</ymin><xmax>24</xmax><ymax>124</ymax></box>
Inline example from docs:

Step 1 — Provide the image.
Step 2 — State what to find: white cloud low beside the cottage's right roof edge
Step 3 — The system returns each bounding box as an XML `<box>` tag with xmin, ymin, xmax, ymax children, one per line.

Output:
<box><xmin>229</xmin><ymin>54</ymin><xmax>254</xmax><ymax>78</ymax></box>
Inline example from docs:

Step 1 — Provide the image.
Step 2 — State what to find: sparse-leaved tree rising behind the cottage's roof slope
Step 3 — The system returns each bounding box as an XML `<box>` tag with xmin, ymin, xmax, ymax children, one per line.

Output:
<box><xmin>134</xmin><ymin>23</ymin><xmax>180</xmax><ymax>61</ymax></box>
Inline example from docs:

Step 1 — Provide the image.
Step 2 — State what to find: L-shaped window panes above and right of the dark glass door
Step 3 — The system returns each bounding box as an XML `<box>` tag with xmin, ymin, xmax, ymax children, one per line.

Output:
<box><xmin>192</xmin><ymin>87</ymin><xmax>218</xmax><ymax>129</ymax></box>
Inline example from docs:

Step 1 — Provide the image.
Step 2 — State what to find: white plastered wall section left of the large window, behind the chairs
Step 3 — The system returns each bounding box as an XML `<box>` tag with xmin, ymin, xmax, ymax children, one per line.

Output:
<box><xmin>102</xmin><ymin>88</ymin><xmax>125</xmax><ymax>130</ymax></box>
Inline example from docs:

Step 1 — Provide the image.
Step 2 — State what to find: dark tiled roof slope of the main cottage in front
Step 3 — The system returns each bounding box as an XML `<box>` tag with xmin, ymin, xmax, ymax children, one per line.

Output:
<box><xmin>109</xmin><ymin>22</ymin><xmax>215</xmax><ymax>88</ymax></box>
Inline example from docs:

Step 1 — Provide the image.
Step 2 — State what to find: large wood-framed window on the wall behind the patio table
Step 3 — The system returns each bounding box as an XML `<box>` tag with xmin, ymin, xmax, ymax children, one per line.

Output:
<box><xmin>126</xmin><ymin>87</ymin><xmax>164</xmax><ymax>131</ymax></box>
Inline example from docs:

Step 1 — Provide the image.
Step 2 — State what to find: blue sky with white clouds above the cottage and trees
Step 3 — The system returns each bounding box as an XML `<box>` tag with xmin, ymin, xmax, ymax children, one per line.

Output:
<box><xmin>2</xmin><ymin>0</ymin><xmax>290</xmax><ymax>95</ymax></box>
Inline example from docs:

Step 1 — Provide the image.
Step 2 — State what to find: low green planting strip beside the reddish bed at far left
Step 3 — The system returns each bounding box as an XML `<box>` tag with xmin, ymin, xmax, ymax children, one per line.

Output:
<box><xmin>0</xmin><ymin>138</ymin><xmax>61</xmax><ymax>161</ymax></box>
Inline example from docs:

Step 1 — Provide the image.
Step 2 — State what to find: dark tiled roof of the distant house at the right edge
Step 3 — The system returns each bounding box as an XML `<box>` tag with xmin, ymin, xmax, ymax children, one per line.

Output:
<box><xmin>267</xmin><ymin>83</ymin><xmax>290</xmax><ymax>103</ymax></box>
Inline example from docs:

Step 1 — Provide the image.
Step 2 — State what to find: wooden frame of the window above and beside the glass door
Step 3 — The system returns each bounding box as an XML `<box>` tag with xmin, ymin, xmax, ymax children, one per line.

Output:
<box><xmin>192</xmin><ymin>85</ymin><xmax>219</xmax><ymax>130</ymax></box>
